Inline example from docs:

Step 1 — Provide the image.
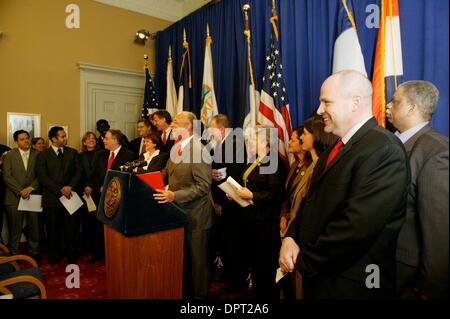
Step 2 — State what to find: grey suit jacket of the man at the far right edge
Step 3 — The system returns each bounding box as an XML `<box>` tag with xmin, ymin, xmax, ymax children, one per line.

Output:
<box><xmin>397</xmin><ymin>126</ymin><xmax>449</xmax><ymax>298</ymax></box>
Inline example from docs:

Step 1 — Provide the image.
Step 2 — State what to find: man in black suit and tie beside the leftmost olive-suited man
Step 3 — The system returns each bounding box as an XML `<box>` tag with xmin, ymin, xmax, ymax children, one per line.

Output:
<box><xmin>36</xmin><ymin>126</ymin><xmax>82</xmax><ymax>264</ymax></box>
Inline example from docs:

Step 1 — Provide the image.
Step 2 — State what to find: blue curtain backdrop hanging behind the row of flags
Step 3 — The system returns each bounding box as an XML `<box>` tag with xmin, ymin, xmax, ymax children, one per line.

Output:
<box><xmin>155</xmin><ymin>0</ymin><xmax>449</xmax><ymax>136</ymax></box>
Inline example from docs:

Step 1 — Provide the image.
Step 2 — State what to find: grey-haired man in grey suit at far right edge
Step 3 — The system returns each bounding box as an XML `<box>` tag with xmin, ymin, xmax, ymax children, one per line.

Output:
<box><xmin>387</xmin><ymin>81</ymin><xmax>449</xmax><ymax>298</ymax></box>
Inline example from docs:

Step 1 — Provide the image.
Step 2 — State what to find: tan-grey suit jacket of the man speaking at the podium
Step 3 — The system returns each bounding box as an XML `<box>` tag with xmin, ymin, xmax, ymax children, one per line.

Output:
<box><xmin>161</xmin><ymin>137</ymin><xmax>212</xmax><ymax>231</ymax></box>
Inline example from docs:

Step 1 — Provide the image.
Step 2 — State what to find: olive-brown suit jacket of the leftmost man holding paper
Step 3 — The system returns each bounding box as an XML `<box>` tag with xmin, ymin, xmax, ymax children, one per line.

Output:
<box><xmin>3</xmin><ymin>148</ymin><xmax>39</xmax><ymax>206</ymax></box>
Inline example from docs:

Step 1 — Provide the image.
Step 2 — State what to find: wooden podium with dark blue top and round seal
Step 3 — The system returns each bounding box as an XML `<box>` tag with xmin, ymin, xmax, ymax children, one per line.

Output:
<box><xmin>97</xmin><ymin>170</ymin><xmax>186</xmax><ymax>299</ymax></box>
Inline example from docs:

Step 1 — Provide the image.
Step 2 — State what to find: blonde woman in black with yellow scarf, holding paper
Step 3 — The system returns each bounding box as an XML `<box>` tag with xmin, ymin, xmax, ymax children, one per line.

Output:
<box><xmin>232</xmin><ymin>126</ymin><xmax>284</xmax><ymax>299</ymax></box>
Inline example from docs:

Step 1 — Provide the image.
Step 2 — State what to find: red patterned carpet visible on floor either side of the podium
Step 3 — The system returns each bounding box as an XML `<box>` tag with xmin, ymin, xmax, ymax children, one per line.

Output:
<box><xmin>39</xmin><ymin>254</ymin><xmax>251</xmax><ymax>299</ymax></box>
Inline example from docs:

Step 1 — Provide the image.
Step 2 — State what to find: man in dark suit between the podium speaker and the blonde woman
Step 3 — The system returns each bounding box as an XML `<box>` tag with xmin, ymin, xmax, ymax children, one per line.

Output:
<box><xmin>210</xmin><ymin>114</ymin><xmax>248</xmax><ymax>292</ymax></box>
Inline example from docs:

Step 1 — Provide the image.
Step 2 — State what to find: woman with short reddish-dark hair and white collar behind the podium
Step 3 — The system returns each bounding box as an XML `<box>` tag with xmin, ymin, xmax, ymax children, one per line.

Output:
<box><xmin>134</xmin><ymin>131</ymin><xmax>169</xmax><ymax>173</ymax></box>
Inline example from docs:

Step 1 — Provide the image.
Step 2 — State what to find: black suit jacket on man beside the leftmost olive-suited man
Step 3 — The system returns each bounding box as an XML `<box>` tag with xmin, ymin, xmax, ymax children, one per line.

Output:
<box><xmin>36</xmin><ymin>147</ymin><xmax>82</xmax><ymax>207</ymax></box>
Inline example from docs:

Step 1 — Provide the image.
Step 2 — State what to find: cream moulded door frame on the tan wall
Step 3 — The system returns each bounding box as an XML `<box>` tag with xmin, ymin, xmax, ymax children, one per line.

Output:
<box><xmin>78</xmin><ymin>62</ymin><xmax>145</xmax><ymax>139</ymax></box>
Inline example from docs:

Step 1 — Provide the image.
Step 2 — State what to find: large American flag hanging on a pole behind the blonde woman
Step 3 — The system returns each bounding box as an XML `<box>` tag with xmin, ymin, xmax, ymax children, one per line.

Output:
<box><xmin>257</xmin><ymin>26</ymin><xmax>292</xmax><ymax>165</ymax></box>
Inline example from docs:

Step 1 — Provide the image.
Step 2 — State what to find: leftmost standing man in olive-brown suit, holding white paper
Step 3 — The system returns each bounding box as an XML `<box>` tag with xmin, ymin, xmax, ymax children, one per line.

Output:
<box><xmin>3</xmin><ymin>130</ymin><xmax>41</xmax><ymax>261</ymax></box>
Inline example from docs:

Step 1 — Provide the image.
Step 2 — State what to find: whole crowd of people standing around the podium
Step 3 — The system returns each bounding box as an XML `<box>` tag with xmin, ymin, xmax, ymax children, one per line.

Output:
<box><xmin>0</xmin><ymin>71</ymin><xmax>449</xmax><ymax>300</ymax></box>
